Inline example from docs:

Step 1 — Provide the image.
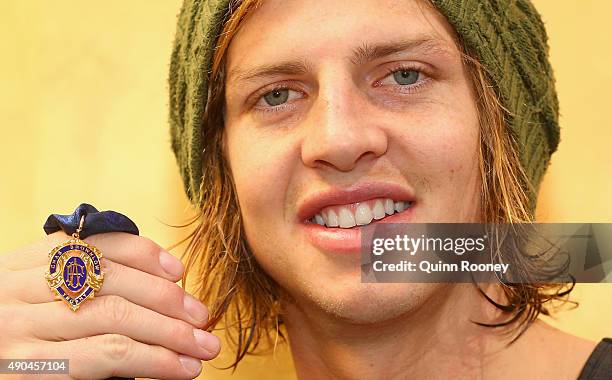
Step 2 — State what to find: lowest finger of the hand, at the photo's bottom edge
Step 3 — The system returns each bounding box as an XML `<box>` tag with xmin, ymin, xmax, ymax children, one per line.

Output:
<box><xmin>32</xmin><ymin>334</ymin><xmax>202</xmax><ymax>379</ymax></box>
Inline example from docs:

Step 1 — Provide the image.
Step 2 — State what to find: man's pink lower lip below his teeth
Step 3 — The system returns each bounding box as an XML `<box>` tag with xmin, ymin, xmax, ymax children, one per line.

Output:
<box><xmin>302</xmin><ymin>204</ymin><xmax>415</xmax><ymax>254</ymax></box>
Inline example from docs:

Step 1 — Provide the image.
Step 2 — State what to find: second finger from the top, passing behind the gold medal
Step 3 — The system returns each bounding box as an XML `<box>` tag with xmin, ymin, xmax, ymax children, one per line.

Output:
<box><xmin>0</xmin><ymin>258</ymin><xmax>208</xmax><ymax>327</ymax></box>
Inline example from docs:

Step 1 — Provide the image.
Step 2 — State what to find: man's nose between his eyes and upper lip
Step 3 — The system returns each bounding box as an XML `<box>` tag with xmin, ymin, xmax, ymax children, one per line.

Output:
<box><xmin>301</xmin><ymin>74</ymin><xmax>388</xmax><ymax>172</ymax></box>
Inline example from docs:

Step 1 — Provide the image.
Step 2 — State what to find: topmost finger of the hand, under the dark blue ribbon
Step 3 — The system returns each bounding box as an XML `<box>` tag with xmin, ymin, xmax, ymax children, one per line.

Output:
<box><xmin>2</xmin><ymin>231</ymin><xmax>184</xmax><ymax>282</ymax></box>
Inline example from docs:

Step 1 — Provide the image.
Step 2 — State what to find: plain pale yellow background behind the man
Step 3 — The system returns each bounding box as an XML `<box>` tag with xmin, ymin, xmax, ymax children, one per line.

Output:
<box><xmin>0</xmin><ymin>0</ymin><xmax>612</xmax><ymax>379</ymax></box>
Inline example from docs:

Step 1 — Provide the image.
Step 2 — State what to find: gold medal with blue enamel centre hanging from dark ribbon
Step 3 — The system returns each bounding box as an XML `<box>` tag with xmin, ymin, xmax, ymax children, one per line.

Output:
<box><xmin>45</xmin><ymin>238</ymin><xmax>104</xmax><ymax>311</ymax></box>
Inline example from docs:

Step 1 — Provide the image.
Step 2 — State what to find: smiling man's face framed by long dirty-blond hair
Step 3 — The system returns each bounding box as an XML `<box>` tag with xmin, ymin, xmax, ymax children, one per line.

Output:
<box><xmin>225</xmin><ymin>0</ymin><xmax>480</xmax><ymax>323</ymax></box>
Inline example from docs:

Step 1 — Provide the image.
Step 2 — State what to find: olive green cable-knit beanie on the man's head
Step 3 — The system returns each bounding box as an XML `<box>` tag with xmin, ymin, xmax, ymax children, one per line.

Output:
<box><xmin>169</xmin><ymin>0</ymin><xmax>559</xmax><ymax>211</ymax></box>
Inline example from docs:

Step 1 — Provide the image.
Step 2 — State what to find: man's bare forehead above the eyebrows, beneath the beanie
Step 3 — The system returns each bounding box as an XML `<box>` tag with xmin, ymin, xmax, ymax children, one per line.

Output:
<box><xmin>227</xmin><ymin>0</ymin><xmax>457</xmax><ymax>72</ymax></box>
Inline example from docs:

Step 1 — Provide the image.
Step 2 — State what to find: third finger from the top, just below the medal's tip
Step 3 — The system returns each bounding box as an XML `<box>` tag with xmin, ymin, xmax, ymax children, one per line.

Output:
<box><xmin>18</xmin><ymin>295</ymin><xmax>221</xmax><ymax>360</ymax></box>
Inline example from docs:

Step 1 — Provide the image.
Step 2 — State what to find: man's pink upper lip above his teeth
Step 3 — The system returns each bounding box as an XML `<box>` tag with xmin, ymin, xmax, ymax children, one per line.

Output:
<box><xmin>297</xmin><ymin>182</ymin><xmax>414</xmax><ymax>221</ymax></box>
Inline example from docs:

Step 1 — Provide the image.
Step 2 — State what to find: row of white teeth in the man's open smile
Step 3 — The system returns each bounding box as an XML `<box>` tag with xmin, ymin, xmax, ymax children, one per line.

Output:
<box><xmin>308</xmin><ymin>198</ymin><xmax>414</xmax><ymax>228</ymax></box>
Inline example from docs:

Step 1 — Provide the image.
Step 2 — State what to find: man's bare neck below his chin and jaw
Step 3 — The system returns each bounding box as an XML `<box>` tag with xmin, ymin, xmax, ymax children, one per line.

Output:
<box><xmin>284</xmin><ymin>284</ymin><xmax>507</xmax><ymax>379</ymax></box>
